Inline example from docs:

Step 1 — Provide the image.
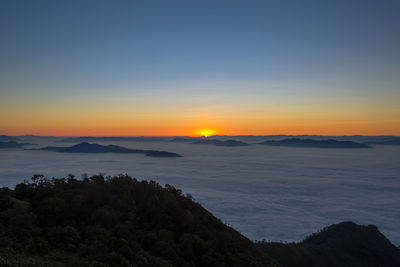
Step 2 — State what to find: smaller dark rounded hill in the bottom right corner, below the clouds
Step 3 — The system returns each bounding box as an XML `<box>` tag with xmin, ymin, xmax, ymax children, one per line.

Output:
<box><xmin>257</xmin><ymin>222</ymin><xmax>400</xmax><ymax>267</ymax></box>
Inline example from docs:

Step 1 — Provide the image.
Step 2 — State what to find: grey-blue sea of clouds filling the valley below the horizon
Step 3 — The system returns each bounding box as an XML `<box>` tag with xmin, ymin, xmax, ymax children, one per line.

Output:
<box><xmin>0</xmin><ymin>138</ymin><xmax>400</xmax><ymax>245</ymax></box>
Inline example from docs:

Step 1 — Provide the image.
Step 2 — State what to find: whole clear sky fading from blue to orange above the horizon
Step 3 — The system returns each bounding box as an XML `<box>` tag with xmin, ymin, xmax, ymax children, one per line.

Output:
<box><xmin>0</xmin><ymin>0</ymin><xmax>400</xmax><ymax>136</ymax></box>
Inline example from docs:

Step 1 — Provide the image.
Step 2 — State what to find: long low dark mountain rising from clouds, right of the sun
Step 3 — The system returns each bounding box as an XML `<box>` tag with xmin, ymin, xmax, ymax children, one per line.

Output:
<box><xmin>259</xmin><ymin>138</ymin><xmax>370</xmax><ymax>148</ymax></box>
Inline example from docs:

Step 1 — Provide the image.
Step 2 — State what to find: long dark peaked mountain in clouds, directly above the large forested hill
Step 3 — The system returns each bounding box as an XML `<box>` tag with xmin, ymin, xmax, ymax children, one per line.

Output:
<box><xmin>34</xmin><ymin>142</ymin><xmax>182</xmax><ymax>157</ymax></box>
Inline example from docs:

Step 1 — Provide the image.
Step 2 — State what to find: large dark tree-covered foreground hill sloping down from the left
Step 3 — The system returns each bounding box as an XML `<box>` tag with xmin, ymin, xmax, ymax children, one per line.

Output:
<box><xmin>0</xmin><ymin>175</ymin><xmax>277</xmax><ymax>267</ymax></box>
